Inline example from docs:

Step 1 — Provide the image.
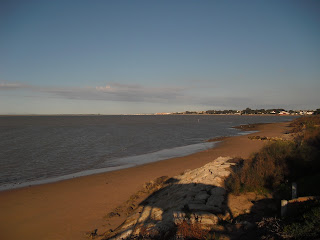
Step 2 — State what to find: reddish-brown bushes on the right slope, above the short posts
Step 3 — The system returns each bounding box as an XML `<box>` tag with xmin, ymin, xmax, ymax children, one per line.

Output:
<box><xmin>226</xmin><ymin>116</ymin><xmax>320</xmax><ymax>194</ymax></box>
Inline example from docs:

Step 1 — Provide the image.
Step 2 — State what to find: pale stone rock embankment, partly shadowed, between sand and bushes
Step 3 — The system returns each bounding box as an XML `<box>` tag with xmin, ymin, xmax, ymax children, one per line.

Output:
<box><xmin>107</xmin><ymin>157</ymin><xmax>234</xmax><ymax>240</ymax></box>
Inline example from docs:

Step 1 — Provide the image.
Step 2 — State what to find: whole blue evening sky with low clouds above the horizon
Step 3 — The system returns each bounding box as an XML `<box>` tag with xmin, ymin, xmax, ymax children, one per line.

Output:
<box><xmin>0</xmin><ymin>0</ymin><xmax>320</xmax><ymax>114</ymax></box>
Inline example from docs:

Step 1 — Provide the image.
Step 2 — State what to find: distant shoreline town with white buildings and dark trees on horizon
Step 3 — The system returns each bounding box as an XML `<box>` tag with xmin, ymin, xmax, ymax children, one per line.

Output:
<box><xmin>155</xmin><ymin>108</ymin><xmax>320</xmax><ymax>116</ymax></box>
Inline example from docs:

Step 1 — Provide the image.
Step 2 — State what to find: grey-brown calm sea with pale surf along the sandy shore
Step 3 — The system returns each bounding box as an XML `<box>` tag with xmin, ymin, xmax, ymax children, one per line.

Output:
<box><xmin>0</xmin><ymin>115</ymin><xmax>293</xmax><ymax>190</ymax></box>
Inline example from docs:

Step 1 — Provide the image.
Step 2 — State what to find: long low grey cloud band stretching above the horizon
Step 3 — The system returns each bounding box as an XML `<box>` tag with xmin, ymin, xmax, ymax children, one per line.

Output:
<box><xmin>0</xmin><ymin>82</ymin><xmax>318</xmax><ymax>109</ymax></box>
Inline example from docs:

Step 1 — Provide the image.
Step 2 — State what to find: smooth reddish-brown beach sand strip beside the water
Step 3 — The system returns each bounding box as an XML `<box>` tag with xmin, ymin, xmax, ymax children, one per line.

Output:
<box><xmin>0</xmin><ymin>122</ymin><xmax>289</xmax><ymax>240</ymax></box>
